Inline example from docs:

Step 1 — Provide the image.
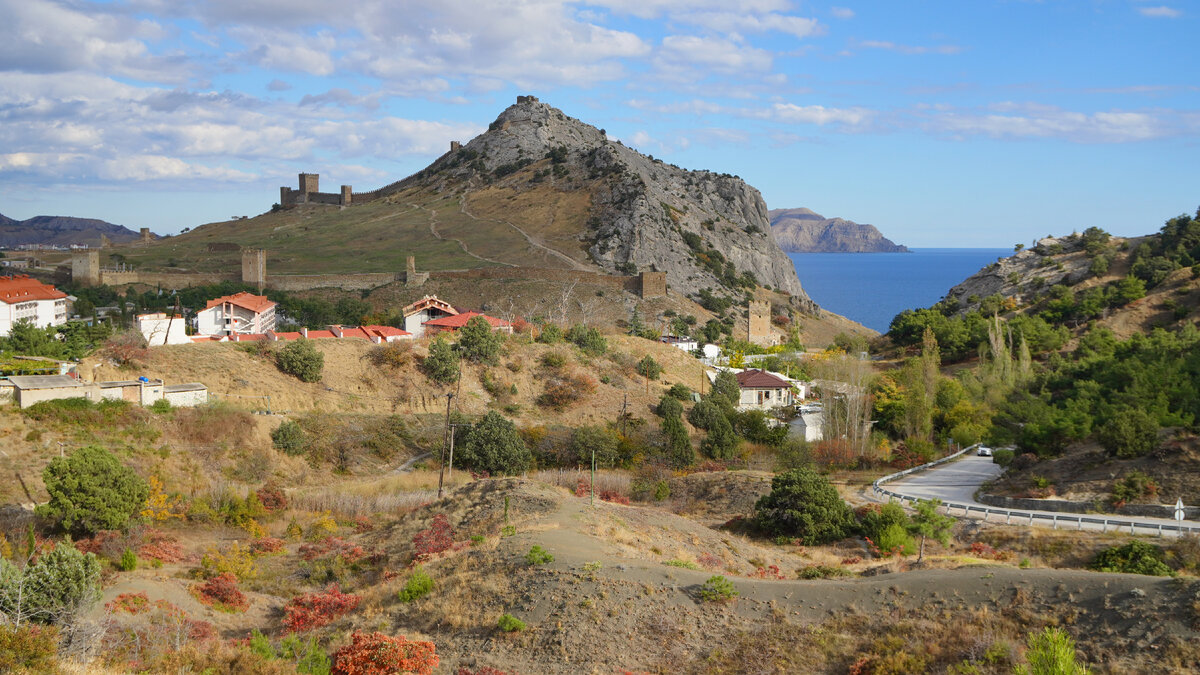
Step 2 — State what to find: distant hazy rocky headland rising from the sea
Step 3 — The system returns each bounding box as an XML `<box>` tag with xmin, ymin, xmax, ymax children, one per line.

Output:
<box><xmin>768</xmin><ymin>209</ymin><xmax>908</xmax><ymax>253</ymax></box>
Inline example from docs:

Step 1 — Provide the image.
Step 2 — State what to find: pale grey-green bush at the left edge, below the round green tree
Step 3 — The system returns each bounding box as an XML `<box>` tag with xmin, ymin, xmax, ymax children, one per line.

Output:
<box><xmin>0</xmin><ymin>543</ymin><xmax>100</xmax><ymax>623</ymax></box>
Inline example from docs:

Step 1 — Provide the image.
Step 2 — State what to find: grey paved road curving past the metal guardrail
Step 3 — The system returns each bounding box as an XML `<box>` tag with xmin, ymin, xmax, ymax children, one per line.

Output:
<box><xmin>884</xmin><ymin>454</ymin><xmax>1200</xmax><ymax>536</ymax></box>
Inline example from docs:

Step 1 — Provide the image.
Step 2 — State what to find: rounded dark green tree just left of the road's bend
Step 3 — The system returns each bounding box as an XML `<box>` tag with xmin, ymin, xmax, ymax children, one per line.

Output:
<box><xmin>754</xmin><ymin>467</ymin><xmax>854</xmax><ymax>545</ymax></box>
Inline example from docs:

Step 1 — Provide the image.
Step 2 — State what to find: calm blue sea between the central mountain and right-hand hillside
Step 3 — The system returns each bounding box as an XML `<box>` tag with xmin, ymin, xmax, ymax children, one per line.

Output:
<box><xmin>788</xmin><ymin>249</ymin><xmax>1013</xmax><ymax>333</ymax></box>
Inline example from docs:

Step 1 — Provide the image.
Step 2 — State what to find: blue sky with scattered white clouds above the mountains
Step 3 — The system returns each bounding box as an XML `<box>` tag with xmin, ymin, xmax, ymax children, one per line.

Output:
<box><xmin>0</xmin><ymin>0</ymin><xmax>1200</xmax><ymax>247</ymax></box>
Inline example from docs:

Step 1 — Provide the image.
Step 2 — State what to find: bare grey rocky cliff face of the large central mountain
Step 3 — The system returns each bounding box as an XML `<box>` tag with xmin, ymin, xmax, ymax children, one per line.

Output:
<box><xmin>415</xmin><ymin>96</ymin><xmax>811</xmax><ymax>305</ymax></box>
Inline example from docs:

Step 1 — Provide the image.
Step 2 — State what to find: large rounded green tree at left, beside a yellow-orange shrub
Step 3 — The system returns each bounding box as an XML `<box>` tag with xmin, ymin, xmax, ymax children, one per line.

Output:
<box><xmin>37</xmin><ymin>446</ymin><xmax>150</xmax><ymax>534</ymax></box>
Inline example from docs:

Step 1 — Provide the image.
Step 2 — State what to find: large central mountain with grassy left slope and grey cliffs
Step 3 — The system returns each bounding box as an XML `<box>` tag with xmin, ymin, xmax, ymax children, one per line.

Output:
<box><xmin>121</xmin><ymin>96</ymin><xmax>815</xmax><ymax>309</ymax></box>
